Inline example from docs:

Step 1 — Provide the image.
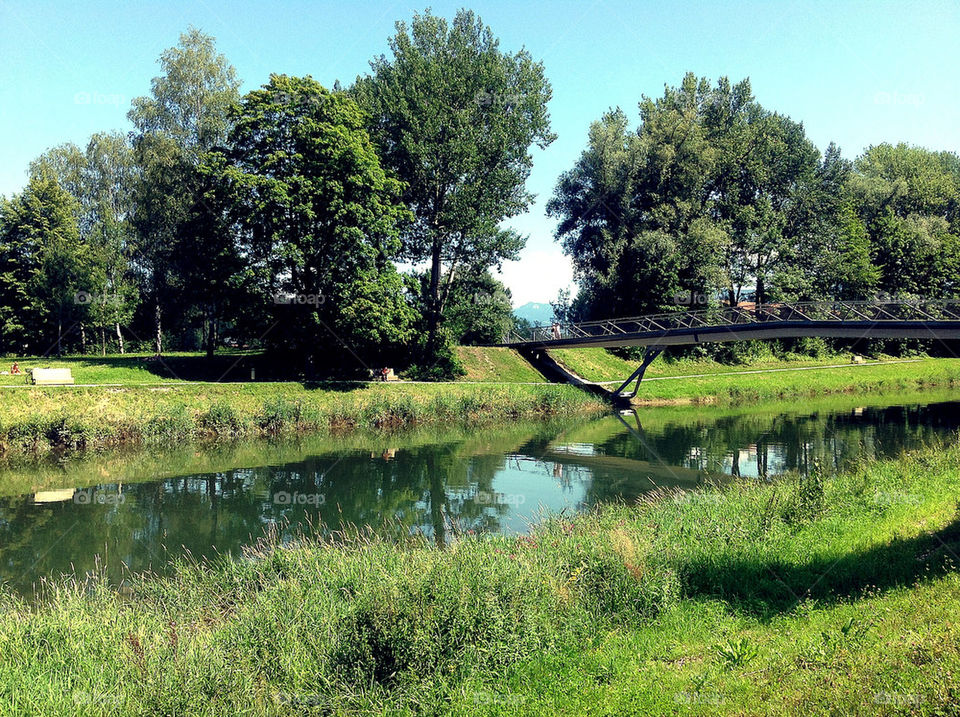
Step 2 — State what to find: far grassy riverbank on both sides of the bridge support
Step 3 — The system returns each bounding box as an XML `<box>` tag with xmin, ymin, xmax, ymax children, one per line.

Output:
<box><xmin>0</xmin><ymin>349</ymin><xmax>960</xmax><ymax>454</ymax></box>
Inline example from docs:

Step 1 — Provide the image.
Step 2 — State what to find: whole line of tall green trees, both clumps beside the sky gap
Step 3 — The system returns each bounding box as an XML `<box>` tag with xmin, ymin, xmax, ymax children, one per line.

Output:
<box><xmin>0</xmin><ymin>11</ymin><xmax>960</xmax><ymax>376</ymax></box>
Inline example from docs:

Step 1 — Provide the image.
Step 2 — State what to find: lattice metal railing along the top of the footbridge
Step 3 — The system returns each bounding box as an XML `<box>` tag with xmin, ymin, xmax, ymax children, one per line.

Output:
<box><xmin>503</xmin><ymin>299</ymin><xmax>960</xmax><ymax>344</ymax></box>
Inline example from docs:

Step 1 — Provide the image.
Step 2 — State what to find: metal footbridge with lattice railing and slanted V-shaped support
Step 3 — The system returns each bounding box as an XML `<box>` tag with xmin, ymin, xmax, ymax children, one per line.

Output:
<box><xmin>500</xmin><ymin>300</ymin><xmax>960</xmax><ymax>398</ymax></box>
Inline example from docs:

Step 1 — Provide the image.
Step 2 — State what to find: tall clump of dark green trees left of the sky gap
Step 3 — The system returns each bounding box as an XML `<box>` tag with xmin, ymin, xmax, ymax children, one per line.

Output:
<box><xmin>0</xmin><ymin>11</ymin><xmax>540</xmax><ymax>375</ymax></box>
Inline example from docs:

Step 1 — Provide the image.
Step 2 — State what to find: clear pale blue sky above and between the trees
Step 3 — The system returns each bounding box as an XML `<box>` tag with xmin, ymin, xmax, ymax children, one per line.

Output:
<box><xmin>0</xmin><ymin>0</ymin><xmax>960</xmax><ymax>304</ymax></box>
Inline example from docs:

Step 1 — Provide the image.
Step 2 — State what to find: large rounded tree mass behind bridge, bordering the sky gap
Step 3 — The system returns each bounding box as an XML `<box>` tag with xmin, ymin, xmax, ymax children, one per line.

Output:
<box><xmin>547</xmin><ymin>74</ymin><xmax>819</xmax><ymax>318</ymax></box>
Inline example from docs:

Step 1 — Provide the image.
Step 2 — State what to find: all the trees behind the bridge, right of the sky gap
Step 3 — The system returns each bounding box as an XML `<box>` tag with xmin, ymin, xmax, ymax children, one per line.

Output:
<box><xmin>548</xmin><ymin>74</ymin><xmax>960</xmax><ymax>319</ymax></box>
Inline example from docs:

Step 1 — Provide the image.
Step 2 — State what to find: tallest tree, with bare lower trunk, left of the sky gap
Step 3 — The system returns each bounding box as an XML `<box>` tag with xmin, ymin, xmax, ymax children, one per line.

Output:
<box><xmin>353</xmin><ymin>10</ymin><xmax>554</xmax><ymax>351</ymax></box>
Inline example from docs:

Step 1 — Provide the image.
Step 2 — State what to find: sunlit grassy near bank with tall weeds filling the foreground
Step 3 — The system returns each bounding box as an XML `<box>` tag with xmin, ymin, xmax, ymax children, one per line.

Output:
<box><xmin>0</xmin><ymin>436</ymin><xmax>960</xmax><ymax>714</ymax></box>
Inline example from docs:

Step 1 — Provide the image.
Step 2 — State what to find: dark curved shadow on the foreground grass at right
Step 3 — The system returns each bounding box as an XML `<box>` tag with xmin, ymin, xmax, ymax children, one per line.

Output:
<box><xmin>679</xmin><ymin>510</ymin><xmax>960</xmax><ymax>617</ymax></box>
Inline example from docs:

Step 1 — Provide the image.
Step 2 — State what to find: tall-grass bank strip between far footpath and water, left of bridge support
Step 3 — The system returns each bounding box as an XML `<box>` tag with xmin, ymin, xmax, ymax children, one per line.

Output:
<box><xmin>0</xmin><ymin>383</ymin><xmax>605</xmax><ymax>452</ymax></box>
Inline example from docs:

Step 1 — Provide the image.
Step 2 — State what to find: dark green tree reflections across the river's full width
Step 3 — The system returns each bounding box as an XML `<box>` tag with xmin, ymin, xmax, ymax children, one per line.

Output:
<box><xmin>0</xmin><ymin>404</ymin><xmax>960</xmax><ymax>592</ymax></box>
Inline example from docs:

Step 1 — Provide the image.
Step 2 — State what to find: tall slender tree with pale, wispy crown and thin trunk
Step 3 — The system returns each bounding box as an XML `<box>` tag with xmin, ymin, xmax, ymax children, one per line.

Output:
<box><xmin>128</xmin><ymin>28</ymin><xmax>240</xmax><ymax>355</ymax></box>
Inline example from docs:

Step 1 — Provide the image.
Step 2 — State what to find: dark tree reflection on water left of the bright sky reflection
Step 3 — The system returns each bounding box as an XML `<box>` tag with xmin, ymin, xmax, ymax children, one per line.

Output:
<box><xmin>0</xmin><ymin>430</ymin><xmax>532</xmax><ymax>593</ymax></box>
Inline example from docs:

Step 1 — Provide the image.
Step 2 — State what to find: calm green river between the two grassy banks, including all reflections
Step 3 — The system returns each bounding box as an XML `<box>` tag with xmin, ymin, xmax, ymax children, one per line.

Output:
<box><xmin>0</xmin><ymin>395</ymin><xmax>960</xmax><ymax>595</ymax></box>
